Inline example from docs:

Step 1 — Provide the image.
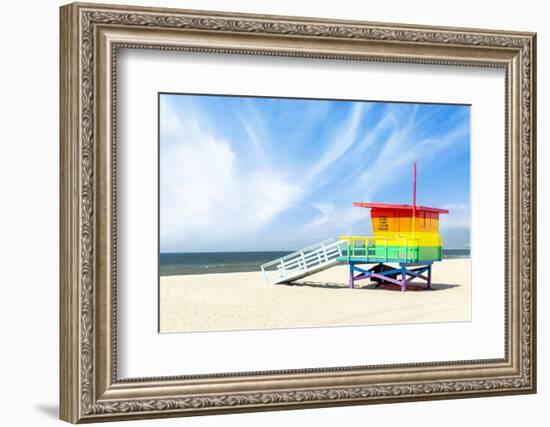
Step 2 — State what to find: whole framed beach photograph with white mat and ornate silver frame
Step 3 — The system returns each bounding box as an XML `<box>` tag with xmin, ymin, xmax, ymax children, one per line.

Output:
<box><xmin>60</xmin><ymin>3</ymin><xmax>536</xmax><ymax>423</ymax></box>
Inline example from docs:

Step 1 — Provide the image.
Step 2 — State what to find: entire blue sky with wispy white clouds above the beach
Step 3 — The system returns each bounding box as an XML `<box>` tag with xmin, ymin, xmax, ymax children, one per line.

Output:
<box><xmin>159</xmin><ymin>94</ymin><xmax>470</xmax><ymax>252</ymax></box>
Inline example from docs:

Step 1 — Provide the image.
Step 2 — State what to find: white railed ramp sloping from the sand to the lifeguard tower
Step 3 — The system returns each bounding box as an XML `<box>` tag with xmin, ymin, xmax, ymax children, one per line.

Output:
<box><xmin>261</xmin><ymin>239</ymin><xmax>347</xmax><ymax>284</ymax></box>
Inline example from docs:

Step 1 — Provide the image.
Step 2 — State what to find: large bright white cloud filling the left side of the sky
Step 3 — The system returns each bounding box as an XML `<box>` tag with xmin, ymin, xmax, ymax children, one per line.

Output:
<box><xmin>160</xmin><ymin>98</ymin><xmax>302</xmax><ymax>251</ymax></box>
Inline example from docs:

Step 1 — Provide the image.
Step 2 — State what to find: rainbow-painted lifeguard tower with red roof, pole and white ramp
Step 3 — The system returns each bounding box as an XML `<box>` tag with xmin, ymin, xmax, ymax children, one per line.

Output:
<box><xmin>261</xmin><ymin>162</ymin><xmax>449</xmax><ymax>291</ymax></box>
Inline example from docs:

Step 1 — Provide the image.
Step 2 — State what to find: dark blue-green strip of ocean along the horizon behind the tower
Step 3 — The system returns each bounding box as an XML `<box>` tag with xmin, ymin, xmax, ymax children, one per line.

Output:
<box><xmin>159</xmin><ymin>249</ymin><xmax>470</xmax><ymax>276</ymax></box>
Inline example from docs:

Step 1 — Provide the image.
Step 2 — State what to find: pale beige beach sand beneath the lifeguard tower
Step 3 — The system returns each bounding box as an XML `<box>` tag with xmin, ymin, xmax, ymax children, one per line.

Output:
<box><xmin>160</xmin><ymin>259</ymin><xmax>471</xmax><ymax>332</ymax></box>
